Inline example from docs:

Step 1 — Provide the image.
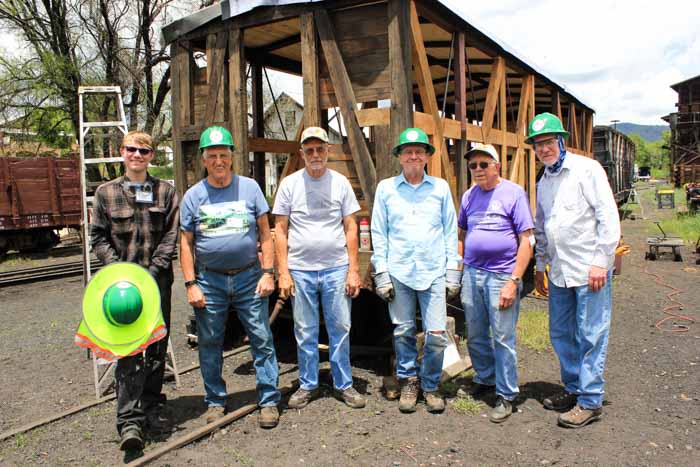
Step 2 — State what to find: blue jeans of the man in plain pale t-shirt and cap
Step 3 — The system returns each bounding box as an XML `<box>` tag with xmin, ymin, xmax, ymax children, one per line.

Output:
<box><xmin>289</xmin><ymin>265</ymin><xmax>352</xmax><ymax>391</ymax></box>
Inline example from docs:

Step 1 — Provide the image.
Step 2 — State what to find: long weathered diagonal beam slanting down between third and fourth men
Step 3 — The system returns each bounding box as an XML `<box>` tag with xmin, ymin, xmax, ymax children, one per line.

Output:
<box><xmin>314</xmin><ymin>10</ymin><xmax>377</xmax><ymax>205</ymax></box>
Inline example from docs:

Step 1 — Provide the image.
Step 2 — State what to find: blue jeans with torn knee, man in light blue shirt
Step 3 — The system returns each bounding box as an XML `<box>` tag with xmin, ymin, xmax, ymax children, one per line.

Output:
<box><xmin>389</xmin><ymin>276</ymin><xmax>447</xmax><ymax>391</ymax></box>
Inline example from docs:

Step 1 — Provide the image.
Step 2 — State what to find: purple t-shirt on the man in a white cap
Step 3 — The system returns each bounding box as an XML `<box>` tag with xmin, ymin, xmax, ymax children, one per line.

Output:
<box><xmin>457</xmin><ymin>180</ymin><xmax>535</xmax><ymax>274</ymax></box>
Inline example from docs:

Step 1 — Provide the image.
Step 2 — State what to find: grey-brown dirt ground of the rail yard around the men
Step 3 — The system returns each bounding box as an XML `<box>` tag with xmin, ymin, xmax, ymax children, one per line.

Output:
<box><xmin>0</xmin><ymin>185</ymin><xmax>700</xmax><ymax>466</ymax></box>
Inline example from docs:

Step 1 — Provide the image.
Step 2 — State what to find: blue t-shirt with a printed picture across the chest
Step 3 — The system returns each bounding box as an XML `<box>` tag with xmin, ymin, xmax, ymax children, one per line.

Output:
<box><xmin>180</xmin><ymin>175</ymin><xmax>270</xmax><ymax>270</ymax></box>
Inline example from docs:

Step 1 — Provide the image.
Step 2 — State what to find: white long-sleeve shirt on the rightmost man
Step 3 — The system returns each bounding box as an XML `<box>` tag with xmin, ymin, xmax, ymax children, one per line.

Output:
<box><xmin>535</xmin><ymin>153</ymin><xmax>620</xmax><ymax>287</ymax></box>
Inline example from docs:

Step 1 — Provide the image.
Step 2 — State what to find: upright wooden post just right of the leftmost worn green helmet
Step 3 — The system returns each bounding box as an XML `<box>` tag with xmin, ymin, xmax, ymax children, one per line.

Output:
<box><xmin>228</xmin><ymin>28</ymin><xmax>250</xmax><ymax>177</ymax></box>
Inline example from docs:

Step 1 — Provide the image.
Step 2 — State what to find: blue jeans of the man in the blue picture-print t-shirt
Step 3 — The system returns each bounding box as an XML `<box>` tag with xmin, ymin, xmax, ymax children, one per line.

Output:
<box><xmin>194</xmin><ymin>264</ymin><xmax>280</xmax><ymax>407</ymax></box>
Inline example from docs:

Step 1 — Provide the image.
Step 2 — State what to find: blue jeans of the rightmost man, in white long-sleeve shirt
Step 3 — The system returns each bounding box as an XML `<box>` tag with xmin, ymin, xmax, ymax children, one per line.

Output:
<box><xmin>549</xmin><ymin>271</ymin><xmax>612</xmax><ymax>409</ymax></box>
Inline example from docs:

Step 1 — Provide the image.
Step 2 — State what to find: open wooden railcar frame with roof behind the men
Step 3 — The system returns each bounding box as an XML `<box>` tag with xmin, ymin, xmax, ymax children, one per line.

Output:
<box><xmin>163</xmin><ymin>0</ymin><xmax>593</xmax><ymax>214</ymax></box>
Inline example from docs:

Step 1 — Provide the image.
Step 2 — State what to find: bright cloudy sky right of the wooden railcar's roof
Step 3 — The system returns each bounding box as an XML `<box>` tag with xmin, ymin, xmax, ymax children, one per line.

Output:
<box><xmin>446</xmin><ymin>0</ymin><xmax>700</xmax><ymax>125</ymax></box>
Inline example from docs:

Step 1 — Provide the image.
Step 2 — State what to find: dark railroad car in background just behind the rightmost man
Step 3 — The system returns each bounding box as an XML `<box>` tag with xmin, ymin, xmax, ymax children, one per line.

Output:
<box><xmin>593</xmin><ymin>125</ymin><xmax>636</xmax><ymax>205</ymax></box>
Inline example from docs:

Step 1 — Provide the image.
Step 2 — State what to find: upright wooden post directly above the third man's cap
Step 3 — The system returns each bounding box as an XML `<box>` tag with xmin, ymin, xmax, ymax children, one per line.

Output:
<box><xmin>299</xmin><ymin>13</ymin><xmax>321</xmax><ymax>128</ymax></box>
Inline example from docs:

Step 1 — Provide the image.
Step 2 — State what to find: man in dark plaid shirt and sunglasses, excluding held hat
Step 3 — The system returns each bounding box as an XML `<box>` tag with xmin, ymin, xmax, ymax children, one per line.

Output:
<box><xmin>91</xmin><ymin>131</ymin><xmax>179</xmax><ymax>450</ymax></box>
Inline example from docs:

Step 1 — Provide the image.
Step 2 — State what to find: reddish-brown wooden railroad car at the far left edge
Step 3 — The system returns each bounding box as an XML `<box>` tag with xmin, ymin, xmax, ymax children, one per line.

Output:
<box><xmin>0</xmin><ymin>157</ymin><xmax>81</xmax><ymax>255</ymax></box>
